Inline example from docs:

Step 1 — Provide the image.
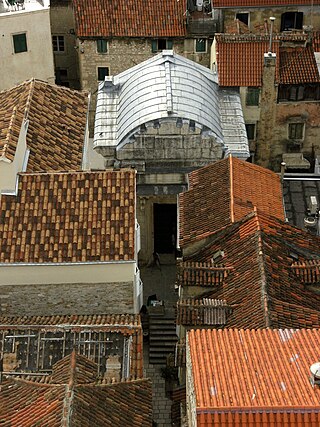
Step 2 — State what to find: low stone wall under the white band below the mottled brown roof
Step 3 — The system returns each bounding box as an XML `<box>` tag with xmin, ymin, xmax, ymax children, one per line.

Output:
<box><xmin>0</xmin><ymin>282</ymin><xmax>134</xmax><ymax>316</ymax></box>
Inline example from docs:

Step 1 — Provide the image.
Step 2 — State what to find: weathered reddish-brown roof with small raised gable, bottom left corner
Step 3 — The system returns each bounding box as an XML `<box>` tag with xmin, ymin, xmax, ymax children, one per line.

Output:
<box><xmin>0</xmin><ymin>352</ymin><xmax>152</xmax><ymax>427</ymax></box>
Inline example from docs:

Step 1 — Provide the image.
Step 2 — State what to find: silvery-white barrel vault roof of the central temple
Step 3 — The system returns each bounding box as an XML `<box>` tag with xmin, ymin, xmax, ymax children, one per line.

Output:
<box><xmin>94</xmin><ymin>50</ymin><xmax>249</xmax><ymax>158</ymax></box>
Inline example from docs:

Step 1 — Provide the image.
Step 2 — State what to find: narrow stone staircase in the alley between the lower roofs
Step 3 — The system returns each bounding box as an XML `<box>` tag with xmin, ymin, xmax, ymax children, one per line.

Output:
<box><xmin>149</xmin><ymin>312</ymin><xmax>177</xmax><ymax>365</ymax></box>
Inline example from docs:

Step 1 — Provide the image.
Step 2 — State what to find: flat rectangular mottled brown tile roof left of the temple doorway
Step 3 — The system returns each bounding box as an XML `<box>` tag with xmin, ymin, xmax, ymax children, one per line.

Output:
<box><xmin>0</xmin><ymin>170</ymin><xmax>135</xmax><ymax>263</ymax></box>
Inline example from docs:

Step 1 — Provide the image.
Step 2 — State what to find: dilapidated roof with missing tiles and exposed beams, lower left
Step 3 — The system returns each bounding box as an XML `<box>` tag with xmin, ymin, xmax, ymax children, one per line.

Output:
<box><xmin>0</xmin><ymin>314</ymin><xmax>143</xmax><ymax>379</ymax></box>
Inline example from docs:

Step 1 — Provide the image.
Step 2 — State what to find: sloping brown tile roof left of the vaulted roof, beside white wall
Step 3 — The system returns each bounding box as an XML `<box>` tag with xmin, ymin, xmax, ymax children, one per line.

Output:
<box><xmin>0</xmin><ymin>79</ymin><xmax>88</xmax><ymax>172</ymax></box>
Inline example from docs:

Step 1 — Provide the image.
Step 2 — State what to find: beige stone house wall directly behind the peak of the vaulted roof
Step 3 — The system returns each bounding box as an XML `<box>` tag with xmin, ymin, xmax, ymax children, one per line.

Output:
<box><xmin>77</xmin><ymin>38</ymin><xmax>211</xmax><ymax>135</ymax></box>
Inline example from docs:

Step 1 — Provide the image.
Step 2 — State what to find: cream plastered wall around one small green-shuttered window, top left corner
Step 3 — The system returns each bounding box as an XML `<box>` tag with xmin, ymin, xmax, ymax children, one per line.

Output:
<box><xmin>0</xmin><ymin>6</ymin><xmax>55</xmax><ymax>90</ymax></box>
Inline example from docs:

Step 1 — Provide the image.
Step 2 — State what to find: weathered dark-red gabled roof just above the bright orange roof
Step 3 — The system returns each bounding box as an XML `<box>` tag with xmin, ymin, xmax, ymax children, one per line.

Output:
<box><xmin>182</xmin><ymin>213</ymin><xmax>320</xmax><ymax>328</ymax></box>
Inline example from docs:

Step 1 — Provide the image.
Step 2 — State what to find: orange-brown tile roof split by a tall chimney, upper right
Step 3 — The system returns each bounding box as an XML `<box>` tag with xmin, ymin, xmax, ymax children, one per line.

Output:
<box><xmin>216</xmin><ymin>34</ymin><xmax>320</xmax><ymax>87</ymax></box>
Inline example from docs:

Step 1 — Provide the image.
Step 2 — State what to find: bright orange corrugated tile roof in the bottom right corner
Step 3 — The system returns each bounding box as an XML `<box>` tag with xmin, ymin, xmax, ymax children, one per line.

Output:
<box><xmin>187</xmin><ymin>329</ymin><xmax>320</xmax><ymax>426</ymax></box>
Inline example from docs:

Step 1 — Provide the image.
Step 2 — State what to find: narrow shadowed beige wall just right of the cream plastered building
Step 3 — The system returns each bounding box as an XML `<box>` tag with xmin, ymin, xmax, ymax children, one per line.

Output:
<box><xmin>50</xmin><ymin>3</ymin><xmax>80</xmax><ymax>89</ymax></box>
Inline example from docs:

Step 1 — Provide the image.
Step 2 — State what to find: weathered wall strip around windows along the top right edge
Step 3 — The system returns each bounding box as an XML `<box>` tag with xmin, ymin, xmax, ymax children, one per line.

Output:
<box><xmin>223</xmin><ymin>5</ymin><xmax>320</xmax><ymax>33</ymax></box>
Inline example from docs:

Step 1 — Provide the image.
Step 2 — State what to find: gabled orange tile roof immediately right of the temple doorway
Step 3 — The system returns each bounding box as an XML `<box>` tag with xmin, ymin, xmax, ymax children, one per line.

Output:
<box><xmin>179</xmin><ymin>157</ymin><xmax>284</xmax><ymax>247</ymax></box>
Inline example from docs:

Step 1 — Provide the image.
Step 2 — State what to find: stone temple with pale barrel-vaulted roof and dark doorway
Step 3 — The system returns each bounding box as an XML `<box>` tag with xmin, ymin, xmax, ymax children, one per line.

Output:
<box><xmin>94</xmin><ymin>50</ymin><xmax>249</xmax><ymax>263</ymax></box>
